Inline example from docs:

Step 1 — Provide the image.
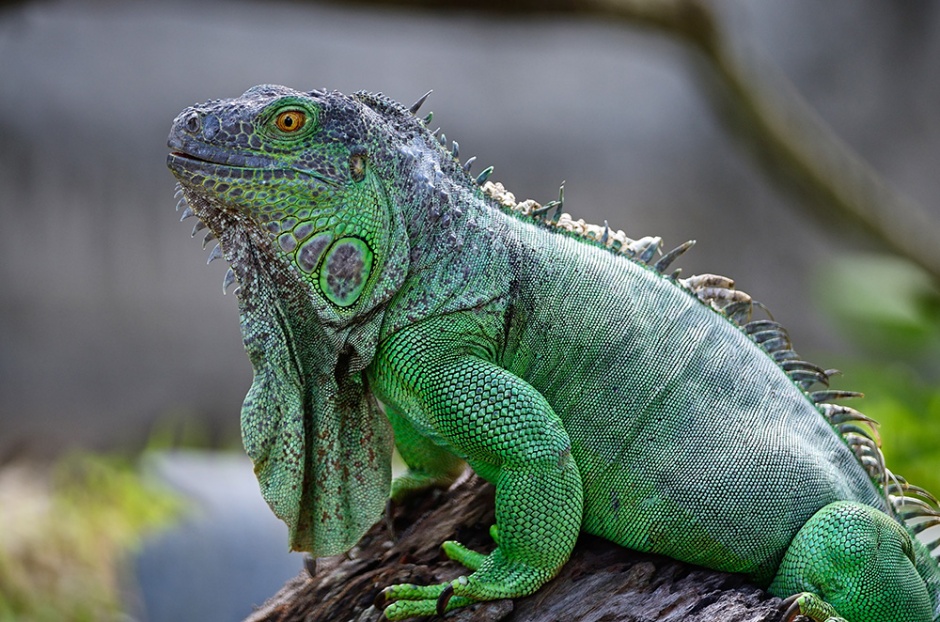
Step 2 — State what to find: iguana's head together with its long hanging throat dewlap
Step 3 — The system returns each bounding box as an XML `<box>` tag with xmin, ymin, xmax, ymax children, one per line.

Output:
<box><xmin>167</xmin><ymin>85</ymin><xmax>434</xmax><ymax>555</ymax></box>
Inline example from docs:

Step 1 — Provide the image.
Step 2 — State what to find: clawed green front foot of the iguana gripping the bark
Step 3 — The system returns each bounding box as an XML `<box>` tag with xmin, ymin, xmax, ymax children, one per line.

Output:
<box><xmin>375</xmin><ymin>541</ymin><xmax>551</xmax><ymax>620</ymax></box>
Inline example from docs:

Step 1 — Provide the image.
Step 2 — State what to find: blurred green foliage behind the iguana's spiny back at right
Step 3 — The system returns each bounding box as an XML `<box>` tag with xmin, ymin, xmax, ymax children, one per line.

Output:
<box><xmin>817</xmin><ymin>255</ymin><xmax>940</xmax><ymax>494</ymax></box>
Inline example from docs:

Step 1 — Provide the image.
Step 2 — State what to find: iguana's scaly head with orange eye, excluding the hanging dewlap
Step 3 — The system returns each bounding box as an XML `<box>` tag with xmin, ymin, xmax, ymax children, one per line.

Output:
<box><xmin>168</xmin><ymin>85</ymin><xmax>408</xmax><ymax>325</ymax></box>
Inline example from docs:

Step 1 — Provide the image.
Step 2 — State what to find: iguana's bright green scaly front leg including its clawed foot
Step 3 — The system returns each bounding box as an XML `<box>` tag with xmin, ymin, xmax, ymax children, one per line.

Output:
<box><xmin>371</xmin><ymin>316</ymin><xmax>582</xmax><ymax>620</ymax></box>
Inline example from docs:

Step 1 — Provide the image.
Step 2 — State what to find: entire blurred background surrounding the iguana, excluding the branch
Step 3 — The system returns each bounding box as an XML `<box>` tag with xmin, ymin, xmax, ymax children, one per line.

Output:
<box><xmin>0</xmin><ymin>0</ymin><xmax>940</xmax><ymax>620</ymax></box>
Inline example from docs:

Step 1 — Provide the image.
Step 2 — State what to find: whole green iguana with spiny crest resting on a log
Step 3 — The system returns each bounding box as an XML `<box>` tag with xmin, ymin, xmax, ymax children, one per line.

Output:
<box><xmin>168</xmin><ymin>85</ymin><xmax>940</xmax><ymax>622</ymax></box>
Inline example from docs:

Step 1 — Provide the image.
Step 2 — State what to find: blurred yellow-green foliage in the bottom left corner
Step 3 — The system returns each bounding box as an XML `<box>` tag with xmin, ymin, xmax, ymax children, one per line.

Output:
<box><xmin>0</xmin><ymin>454</ymin><xmax>181</xmax><ymax>622</ymax></box>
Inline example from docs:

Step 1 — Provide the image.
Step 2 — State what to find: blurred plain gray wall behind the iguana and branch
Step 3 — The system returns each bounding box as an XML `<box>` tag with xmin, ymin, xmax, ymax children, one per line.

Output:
<box><xmin>0</xmin><ymin>0</ymin><xmax>940</xmax><ymax>458</ymax></box>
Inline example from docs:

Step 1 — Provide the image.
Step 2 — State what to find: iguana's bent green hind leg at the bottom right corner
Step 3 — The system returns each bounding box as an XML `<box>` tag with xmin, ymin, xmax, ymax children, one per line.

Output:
<box><xmin>770</xmin><ymin>501</ymin><xmax>932</xmax><ymax>622</ymax></box>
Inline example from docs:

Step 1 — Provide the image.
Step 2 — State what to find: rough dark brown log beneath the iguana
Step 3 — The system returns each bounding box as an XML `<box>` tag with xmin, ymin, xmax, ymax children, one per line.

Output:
<box><xmin>246</xmin><ymin>477</ymin><xmax>781</xmax><ymax>622</ymax></box>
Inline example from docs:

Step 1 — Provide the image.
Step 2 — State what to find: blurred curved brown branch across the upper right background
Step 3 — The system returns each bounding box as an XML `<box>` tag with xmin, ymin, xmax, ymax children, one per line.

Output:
<box><xmin>338</xmin><ymin>0</ymin><xmax>940</xmax><ymax>287</ymax></box>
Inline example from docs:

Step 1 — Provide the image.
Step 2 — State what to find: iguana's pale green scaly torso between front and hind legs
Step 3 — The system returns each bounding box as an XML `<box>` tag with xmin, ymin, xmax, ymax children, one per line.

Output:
<box><xmin>488</xmin><ymin>223</ymin><xmax>887</xmax><ymax>585</ymax></box>
